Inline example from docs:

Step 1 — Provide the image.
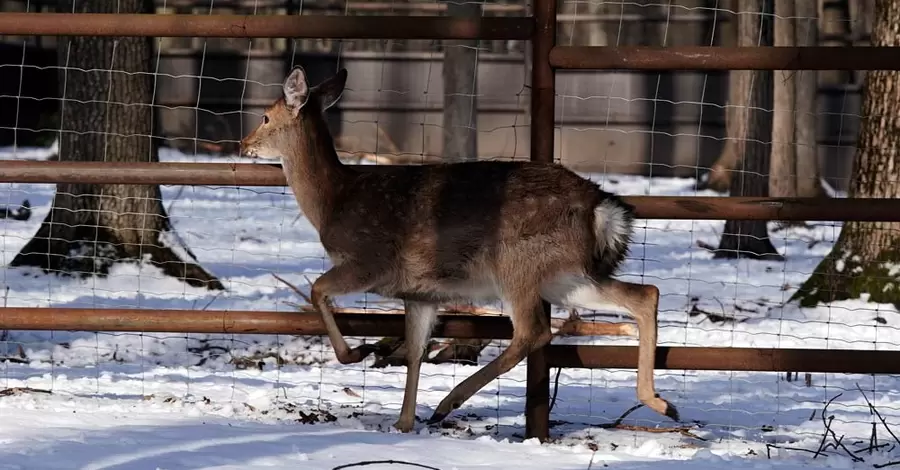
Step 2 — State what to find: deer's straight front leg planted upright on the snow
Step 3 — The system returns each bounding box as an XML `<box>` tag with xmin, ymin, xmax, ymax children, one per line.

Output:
<box><xmin>394</xmin><ymin>301</ymin><xmax>438</xmax><ymax>432</ymax></box>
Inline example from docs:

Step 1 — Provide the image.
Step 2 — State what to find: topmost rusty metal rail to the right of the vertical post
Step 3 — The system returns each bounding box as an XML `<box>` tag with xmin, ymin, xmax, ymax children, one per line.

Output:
<box><xmin>550</xmin><ymin>46</ymin><xmax>900</xmax><ymax>71</ymax></box>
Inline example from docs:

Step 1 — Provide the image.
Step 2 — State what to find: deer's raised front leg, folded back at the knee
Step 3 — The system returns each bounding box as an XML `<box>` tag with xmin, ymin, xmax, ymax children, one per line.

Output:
<box><xmin>310</xmin><ymin>264</ymin><xmax>392</xmax><ymax>364</ymax></box>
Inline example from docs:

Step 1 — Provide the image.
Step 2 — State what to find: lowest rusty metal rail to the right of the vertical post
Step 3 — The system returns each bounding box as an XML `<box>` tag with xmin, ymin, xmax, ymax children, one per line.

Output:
<box><xmin>547</xmin><ymin>345</ymin><xmax>900</xmax><ymax>374</ymax></box>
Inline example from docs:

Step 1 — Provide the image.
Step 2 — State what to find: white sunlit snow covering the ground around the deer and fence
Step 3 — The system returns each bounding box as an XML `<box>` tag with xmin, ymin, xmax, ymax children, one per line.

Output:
<box><xmin>0</xmin><ymin>145</ymin><xmax>900</xmax><ymax>470</ymax></box>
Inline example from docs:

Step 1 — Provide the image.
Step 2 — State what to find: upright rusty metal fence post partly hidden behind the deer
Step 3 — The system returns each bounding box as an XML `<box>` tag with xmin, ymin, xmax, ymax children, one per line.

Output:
<box><xmin>525</xmin><ymin>0</ymin><xmax>557</xmax><ymax>441</ymax></box>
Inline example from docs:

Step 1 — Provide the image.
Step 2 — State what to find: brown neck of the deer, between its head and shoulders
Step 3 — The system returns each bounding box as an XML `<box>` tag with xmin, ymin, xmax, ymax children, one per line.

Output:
<box><xmin>282</xmin><ymin>122</ymin><xmax>349</xmax><ymax>231</ymax></box>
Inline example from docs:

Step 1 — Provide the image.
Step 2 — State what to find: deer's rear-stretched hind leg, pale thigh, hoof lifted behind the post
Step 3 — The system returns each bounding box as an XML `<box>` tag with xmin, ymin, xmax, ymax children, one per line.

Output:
<box><xmin>542</xmin><ymin>276</ymin><xmax>679</xmax><ymax>421</ymax></box>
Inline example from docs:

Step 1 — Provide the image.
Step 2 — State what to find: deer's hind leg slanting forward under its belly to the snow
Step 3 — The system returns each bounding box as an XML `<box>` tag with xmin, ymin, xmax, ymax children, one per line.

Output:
<box><xmin>428</xmin><ymin>293</ymin><xmax>553</xmax><ymax>424</ymax></box>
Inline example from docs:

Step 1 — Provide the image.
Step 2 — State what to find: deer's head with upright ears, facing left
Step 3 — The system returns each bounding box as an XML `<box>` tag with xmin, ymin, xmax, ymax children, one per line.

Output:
<box><xmin>241</xmin><ymin>65</ymin><xmax>347</xmax><ymax>159</ymax></box>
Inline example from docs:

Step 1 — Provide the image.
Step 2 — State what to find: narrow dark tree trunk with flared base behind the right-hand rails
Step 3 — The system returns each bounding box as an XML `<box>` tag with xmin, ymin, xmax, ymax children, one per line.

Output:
<box><xmin>714</xmin><ymin>0</ymin><xmax>783</xmax><ymax>261</ymax></box>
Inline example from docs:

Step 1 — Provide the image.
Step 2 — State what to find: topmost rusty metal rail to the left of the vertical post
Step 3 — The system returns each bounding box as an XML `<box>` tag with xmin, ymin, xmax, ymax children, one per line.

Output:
<box><xmin>0</xmin><ymin>13</ymin><xmax>533</xmax><ymax>40</ymax></box>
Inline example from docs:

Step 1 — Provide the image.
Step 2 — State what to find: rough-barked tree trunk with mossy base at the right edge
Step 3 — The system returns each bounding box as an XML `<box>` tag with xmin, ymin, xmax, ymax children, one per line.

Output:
<box><xmin>791</xmin><ymin>0</ymin><xmax>900</xmax><ymax>307</ymax></box>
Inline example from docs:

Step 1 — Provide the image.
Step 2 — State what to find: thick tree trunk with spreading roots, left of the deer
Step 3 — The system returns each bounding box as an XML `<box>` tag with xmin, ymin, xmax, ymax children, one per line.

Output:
<box><xmin>10</xmin><ymin>0</ymin><xmax>224</xmax><ymax>289</ymax></box>
